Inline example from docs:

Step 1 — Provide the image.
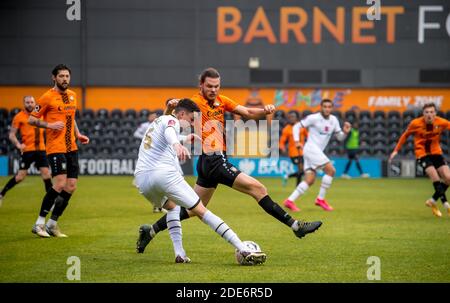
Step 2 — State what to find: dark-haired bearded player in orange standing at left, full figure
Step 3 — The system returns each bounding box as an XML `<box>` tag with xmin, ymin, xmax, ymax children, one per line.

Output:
<box><xmin>29</xmin><ymin>64</ymin><xmax>89</xmax><ymax>238</ymax></box>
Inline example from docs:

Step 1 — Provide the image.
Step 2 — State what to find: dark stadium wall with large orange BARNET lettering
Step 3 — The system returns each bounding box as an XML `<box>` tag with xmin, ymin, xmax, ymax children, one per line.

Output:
<box><xmin>0</xmin><ymin>0</ymin><xmax>450</xmax><ymax>88</ymax></box>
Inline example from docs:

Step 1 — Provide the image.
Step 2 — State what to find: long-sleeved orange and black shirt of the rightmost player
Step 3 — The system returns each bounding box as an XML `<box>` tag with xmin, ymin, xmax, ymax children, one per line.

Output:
<box><xmin>394</xmin><ymin>117</ymin><xmax>450</xmax><ymax>159</ymax></box>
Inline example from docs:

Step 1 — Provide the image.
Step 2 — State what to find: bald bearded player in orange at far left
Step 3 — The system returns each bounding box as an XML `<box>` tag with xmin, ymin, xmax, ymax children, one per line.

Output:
<box><xmin>0</xmin><ymin>96</ymin><xmax>52</xmax><ymax>206</ymax></box>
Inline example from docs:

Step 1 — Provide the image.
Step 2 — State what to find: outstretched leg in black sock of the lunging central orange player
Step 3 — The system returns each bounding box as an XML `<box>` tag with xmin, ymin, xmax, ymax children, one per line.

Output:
<box><xmin>232</xmin><ymin>173</ymin><xmax>322</xmax><ymax>238</ymax></box>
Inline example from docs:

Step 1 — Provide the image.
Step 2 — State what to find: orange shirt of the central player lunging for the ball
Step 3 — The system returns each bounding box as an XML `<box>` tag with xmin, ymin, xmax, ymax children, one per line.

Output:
<box><xmin>191</xmin><ymin>93</ymin><xmax>239</xmax><ymax>153</ymax></box>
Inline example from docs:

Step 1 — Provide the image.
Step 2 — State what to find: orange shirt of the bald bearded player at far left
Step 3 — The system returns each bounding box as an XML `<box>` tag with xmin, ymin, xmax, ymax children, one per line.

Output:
<box><xmin>12</xmin><ymin>110</ymin><xmax>45</xmax><ymax>152</ymax></box>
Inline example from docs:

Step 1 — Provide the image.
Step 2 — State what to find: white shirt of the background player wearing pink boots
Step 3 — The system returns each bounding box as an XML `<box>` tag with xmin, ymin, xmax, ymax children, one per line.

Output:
<box><xmin>293</xmin><ymin>112</ymin><xmax>343</xmax><ymax>151</ymax></box>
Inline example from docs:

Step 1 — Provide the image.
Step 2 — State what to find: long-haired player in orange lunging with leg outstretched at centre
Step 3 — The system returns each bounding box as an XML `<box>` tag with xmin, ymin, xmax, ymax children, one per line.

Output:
<box><xmin>136</xmin><ymin>68</ymin><xmax>322</xmax><ymax>253</ymax></box>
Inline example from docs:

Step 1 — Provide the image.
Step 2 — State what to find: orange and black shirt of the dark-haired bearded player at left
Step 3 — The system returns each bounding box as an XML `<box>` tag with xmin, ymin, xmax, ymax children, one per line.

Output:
<box><xmin>31</xmin><ymin>88</ymin><xmax>78</xmax><ymax>154</ymax></box>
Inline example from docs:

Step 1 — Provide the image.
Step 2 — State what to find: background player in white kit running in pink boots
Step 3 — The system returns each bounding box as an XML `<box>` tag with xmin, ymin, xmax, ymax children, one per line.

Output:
<box><xmin>284</xmin><ymin>99</ymin><xmax>351</xmax><ymax>211</ymax></box>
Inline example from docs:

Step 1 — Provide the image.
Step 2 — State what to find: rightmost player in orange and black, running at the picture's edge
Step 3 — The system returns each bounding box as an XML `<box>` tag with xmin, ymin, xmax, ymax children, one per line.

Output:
<box><xmin>389</xmin><ymin>103</ymin><xmax>450</xmax><ymax>217</ymax></box>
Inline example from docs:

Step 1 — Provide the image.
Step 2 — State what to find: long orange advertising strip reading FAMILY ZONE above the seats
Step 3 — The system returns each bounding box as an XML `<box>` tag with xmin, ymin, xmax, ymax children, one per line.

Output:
<box><xmin>0</xmin><ymin>87</ymin><xmax>450</xmax><ymax>111</ymax></box>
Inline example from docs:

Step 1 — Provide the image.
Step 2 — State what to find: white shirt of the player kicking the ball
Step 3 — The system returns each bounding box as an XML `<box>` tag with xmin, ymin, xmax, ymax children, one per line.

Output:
<box><xmin>134</xmin><ymin>115</ymin><xmax>182</xmax><ymax>176</ymax></box>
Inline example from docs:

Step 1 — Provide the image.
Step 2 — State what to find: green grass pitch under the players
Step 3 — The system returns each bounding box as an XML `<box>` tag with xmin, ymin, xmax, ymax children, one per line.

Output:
<box><xmin>0</xmin><ymin>177</ymin><xmax>450</xmax><ymax>282</ymax></box>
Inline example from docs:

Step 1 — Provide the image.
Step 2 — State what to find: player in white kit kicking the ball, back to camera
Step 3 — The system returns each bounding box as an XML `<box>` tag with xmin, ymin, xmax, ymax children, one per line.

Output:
<box><xmin>134</xmin><ymin>99</ymin><xmax>266</xmax><ymax>265</ymax></box>
